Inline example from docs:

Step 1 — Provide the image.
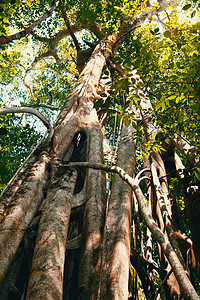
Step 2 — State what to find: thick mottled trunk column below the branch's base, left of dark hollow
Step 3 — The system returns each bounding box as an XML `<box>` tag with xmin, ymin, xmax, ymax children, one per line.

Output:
<box><xmin>26</xmin><ymin>166</ymin><xmax>76</xmax><ymax>300</ymax></box>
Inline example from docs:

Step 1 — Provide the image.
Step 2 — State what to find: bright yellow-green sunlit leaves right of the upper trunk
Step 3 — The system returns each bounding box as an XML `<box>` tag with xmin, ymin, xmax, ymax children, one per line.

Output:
<box><xmin>115</xmin><ymin>13</ymin><xmax>200</xmax><ymax>156</ymax></box>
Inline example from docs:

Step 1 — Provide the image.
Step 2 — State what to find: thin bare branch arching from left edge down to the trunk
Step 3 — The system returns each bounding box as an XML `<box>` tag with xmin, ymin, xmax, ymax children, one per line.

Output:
<box><xmin>0</xmin><ymin>106</ymin><xmax>52</xmax><ymax>130</ymax></box>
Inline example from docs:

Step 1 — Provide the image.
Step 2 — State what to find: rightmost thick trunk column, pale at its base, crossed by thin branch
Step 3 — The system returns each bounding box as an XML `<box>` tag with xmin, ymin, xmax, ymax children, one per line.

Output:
<box><xmin>96</xmin><ymin>125</ymin><xmax>135</xmax><ymax>299</ymax></box>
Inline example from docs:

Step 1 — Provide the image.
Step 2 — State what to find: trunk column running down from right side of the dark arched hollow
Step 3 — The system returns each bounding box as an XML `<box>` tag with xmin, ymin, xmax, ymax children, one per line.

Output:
<box><xmin>78</xmin><ymin>124</ymin><xmax>106</xmax><ymax>299</ymax></box>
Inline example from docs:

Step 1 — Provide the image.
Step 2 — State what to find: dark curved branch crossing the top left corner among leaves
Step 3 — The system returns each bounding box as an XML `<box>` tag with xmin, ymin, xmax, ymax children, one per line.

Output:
<box><xmin>0</xmin><ymin>0</ymin><xmax>57</xmax><ymax>46</ymax></box>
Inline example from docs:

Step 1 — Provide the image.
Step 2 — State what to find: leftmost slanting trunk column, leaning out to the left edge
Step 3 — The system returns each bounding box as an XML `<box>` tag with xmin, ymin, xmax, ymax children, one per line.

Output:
<box><xmin>0</xmin><ymin>153</ymin><xmax>49</xmax><ymax>282</ymax></box>
